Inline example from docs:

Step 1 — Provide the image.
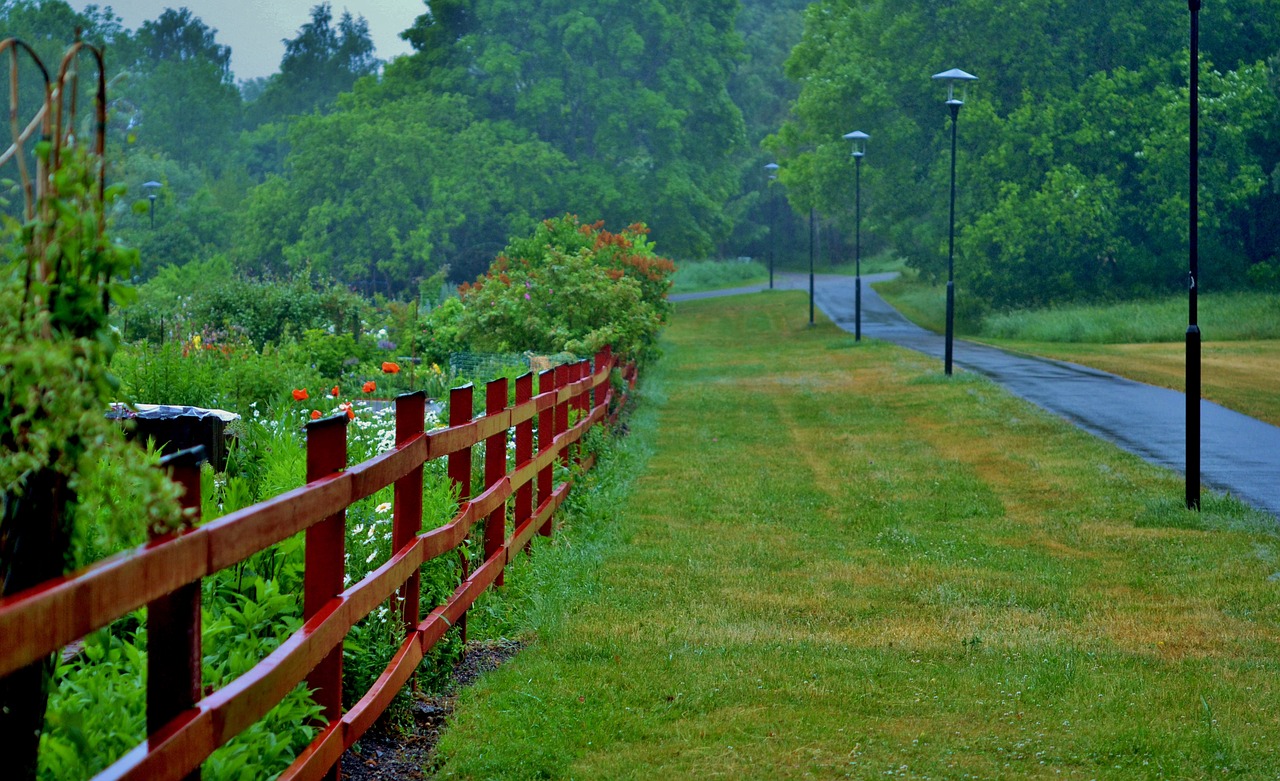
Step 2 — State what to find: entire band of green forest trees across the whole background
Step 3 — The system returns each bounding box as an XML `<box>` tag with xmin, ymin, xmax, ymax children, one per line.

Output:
<box><xmin>0</xmin><ymin>0</ymin><xmax>1280</xmax><ymax>309</ymax></box>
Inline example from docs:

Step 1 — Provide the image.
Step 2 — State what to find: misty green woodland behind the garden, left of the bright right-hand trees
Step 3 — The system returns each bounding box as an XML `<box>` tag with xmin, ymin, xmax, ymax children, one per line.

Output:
<box><xmin>0</xmin><ymin>0</ymin><xmax>803</xmax><ymax>294</ymax></box>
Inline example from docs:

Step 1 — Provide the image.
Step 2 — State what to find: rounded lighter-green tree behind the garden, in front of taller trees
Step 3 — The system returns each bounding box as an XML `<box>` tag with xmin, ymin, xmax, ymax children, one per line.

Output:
<box><xmin>237</xmin><ymin>88</ymin><xmax>573</xmax><ymax>294</ymax></box>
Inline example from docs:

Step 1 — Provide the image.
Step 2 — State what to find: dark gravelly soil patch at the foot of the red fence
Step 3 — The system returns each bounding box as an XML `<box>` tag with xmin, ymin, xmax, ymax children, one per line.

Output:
<box><xmin>342</xmin><ymin>640</ymin><xmax>525</xmax><ymax>781</ymax></box>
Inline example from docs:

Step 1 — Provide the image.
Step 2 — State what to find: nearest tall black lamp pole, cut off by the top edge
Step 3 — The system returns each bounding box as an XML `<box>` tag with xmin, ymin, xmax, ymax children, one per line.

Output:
<box><xmin>1187</xmin><ymin>0</ymin><xmax>1201</xmax><ymax>510</ymax></box>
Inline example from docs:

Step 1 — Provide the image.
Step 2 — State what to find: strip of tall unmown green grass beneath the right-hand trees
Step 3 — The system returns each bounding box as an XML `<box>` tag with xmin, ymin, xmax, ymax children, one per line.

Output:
<box><xmin>979</xmin><ymin>292</ymin><xmax>1280</xmax><ymax>344</ymax></box>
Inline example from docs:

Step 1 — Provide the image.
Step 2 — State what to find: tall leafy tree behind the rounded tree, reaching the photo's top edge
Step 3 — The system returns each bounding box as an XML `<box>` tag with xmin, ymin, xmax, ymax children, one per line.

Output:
<box><xmin>387</xmin><ymin>0</ymin><xmax>745</xmax><ymax>255</ymax></box>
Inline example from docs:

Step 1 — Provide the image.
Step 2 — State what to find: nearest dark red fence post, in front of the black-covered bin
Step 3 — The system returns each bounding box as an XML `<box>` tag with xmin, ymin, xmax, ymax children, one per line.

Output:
<box><xmin>147</xmin><ymin>446</ymin><xmax>205</xmax><ymax>781</ymax></box>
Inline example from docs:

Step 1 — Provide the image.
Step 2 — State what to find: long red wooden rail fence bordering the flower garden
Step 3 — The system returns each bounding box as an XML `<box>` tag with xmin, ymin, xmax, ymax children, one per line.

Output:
<box><xmin>0</xmin><ymin>351</ymin><xmax>635</xmax><ymax>780</ymax></box>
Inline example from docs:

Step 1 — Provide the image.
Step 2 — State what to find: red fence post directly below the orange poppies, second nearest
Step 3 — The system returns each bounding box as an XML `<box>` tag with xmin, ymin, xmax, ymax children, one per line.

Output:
<box><xmin>302</xmin><ymin>414</ymin><xmax>347</xmax><ymax>781</ymax></box>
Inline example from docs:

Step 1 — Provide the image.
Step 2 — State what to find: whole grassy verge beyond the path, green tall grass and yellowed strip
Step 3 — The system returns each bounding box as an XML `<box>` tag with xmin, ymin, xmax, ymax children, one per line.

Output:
<box><xmin>876</xmin><ymin>279</ymin><xmax>1280</xmax><ymax>425</ymax></box>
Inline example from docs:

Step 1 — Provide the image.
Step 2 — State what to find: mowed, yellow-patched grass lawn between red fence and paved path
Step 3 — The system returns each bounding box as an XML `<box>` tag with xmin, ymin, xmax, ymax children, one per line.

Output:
<box><xmin>434</xmin><ymin>293</ymin><xmax>1280</xmax><ymax>780</ymax></box>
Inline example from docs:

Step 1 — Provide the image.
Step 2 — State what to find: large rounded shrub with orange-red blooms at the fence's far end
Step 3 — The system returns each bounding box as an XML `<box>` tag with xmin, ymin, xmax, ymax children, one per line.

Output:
<box><xmin>460</xmin><ymin>215</ymin><xmax>676</xmax><ymax>361</ymax></box>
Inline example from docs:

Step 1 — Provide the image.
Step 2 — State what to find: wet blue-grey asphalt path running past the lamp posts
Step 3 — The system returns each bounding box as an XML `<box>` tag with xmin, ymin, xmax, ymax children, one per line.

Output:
<box><xmin>671</xmin><ymin>274</ymin><xmax>1280</xmax><ymax>517</ymax></box>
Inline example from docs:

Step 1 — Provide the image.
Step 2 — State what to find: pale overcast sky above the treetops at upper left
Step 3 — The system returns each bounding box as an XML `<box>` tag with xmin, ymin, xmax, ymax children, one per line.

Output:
<box><xmin>69</xmin><ymin>0</ymin><xmax>426</xmax><ymax>81</ymax></box>
